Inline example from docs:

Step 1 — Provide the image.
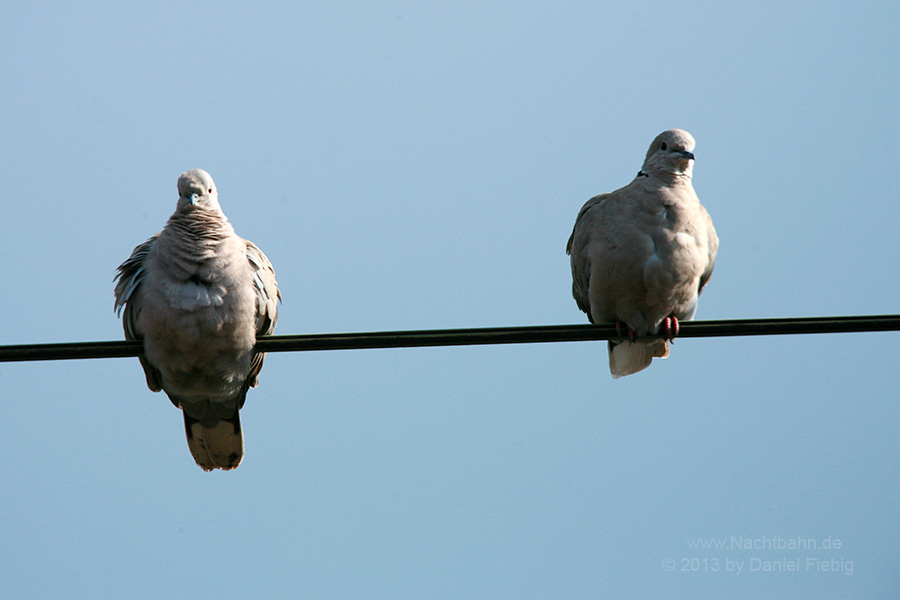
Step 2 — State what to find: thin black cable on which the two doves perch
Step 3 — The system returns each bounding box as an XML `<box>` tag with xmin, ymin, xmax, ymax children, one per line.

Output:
<box><xmin>0</xmin><ymin>315</ymin><xmax>900</xmax><ymax>362</ymax></box>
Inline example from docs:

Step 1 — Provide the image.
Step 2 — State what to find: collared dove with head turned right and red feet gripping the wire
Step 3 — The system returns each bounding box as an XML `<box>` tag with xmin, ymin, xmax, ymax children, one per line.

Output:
<box><xmin>566</xmin><ymin>129</ymin><xmax>719</xmax><ymax>378</ymax></box>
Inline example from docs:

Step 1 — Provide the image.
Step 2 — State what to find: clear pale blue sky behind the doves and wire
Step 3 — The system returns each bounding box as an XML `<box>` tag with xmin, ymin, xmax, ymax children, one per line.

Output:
<box><xmin>0</xmin><ymin>0</ymin><xmax>900</xmax><ymax>599</ymax></box>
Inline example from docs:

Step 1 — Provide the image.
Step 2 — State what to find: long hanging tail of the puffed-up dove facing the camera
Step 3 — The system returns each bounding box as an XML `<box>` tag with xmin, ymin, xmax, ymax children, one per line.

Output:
<box><xmin>184</xmin><ymin>410</ymin><xmax>244</xmax><ymax>471</ymax></box>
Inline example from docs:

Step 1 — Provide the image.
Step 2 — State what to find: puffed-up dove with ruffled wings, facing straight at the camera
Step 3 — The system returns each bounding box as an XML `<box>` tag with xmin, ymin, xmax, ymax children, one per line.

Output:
<box><xmin>115</xmin><ymin>169</ymin><xmax>281</xmax><ymax>471</ymax></box>
